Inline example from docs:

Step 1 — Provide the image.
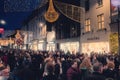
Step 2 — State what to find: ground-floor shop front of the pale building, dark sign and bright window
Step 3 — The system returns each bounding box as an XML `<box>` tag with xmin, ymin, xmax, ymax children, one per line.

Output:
<box><xmin>81</xmin><ymin>32</ymin><xmax>110</xmax><ymax>55</ymax></box>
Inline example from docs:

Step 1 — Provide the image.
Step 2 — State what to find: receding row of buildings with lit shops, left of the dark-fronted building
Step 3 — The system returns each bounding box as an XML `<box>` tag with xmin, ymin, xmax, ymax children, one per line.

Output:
<box><xmin>22</xmin><ymin>5</ymin><xmax>47</xmax><ymax>50</ymax></box>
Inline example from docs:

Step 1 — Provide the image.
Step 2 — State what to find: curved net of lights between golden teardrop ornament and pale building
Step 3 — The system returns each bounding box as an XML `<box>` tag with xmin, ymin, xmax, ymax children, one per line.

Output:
<box><xmin>55</xmin><ymin>1</ymin><xmax>84</xmax><ymax>23</ymax></box>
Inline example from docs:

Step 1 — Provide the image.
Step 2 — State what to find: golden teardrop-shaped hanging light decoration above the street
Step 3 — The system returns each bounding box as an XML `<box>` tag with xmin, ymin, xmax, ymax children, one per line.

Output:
<box><xmin>44</xmin><ymin>0</ymin><xmax>59</xmax><ymax>22</ymax></box>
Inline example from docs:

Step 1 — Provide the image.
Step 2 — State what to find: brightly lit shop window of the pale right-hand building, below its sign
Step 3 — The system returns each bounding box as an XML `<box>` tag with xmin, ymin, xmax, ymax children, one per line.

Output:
<box><xmin>81</xmin><ymin>42</ymin><xmax>110</xmax><ymax>54</ymax></box>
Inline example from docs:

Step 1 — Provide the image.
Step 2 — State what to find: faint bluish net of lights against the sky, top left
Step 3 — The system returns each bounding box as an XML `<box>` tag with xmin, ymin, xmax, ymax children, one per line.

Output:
<box><xmin>4</xmin><ymin>0</ymin><xmax>41</xmax><ymax>12</ymax></box>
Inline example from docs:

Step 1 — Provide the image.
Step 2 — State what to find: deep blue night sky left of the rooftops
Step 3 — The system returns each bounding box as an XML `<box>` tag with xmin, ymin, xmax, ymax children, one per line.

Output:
<box><xmin>0</xmin><ymin>0</ymin><xmax>40</xmax><ymax>30</ymax></box>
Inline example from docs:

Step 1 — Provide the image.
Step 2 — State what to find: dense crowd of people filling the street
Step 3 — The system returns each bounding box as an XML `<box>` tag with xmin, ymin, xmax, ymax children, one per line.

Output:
<box><xmin>0</xmin><ymin>49</ymin><xmax>120</xmax><ymax>80</ymax></box>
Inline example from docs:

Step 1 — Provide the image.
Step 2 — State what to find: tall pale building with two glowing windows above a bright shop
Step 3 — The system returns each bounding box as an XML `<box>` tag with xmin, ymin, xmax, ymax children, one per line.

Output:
<box><xmin>80</xmin><ymin>0</ymin><xmax>111</xmax><ymax>54</ymax></box>
